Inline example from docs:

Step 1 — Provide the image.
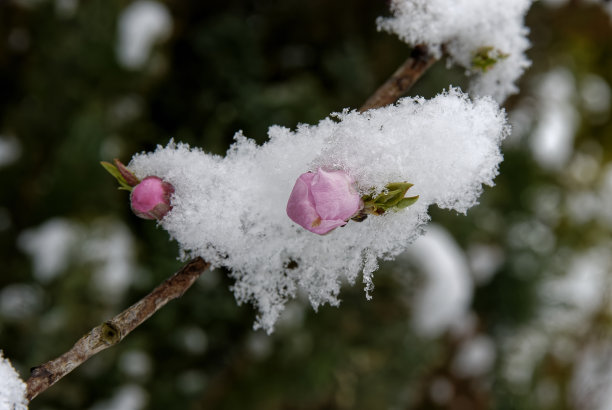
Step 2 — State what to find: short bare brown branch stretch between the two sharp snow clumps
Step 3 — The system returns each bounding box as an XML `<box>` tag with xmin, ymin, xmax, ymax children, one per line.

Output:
<box><xmin>359</xmin><ymin>45</ymin><xmax>437</xmax><ymax>112</ymax></box>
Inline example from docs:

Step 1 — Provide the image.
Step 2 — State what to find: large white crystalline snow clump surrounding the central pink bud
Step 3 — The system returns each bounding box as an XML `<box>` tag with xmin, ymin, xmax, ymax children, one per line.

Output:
<box><xmin>129</xmin><ymin>89</ymin><xmax>508</xmax><ymax>331</ymax></box>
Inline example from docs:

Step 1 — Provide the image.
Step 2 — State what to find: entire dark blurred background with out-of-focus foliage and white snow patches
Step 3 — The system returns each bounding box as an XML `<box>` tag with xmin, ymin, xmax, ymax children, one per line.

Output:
<box><xmin>0</xmin><ymin>0</ymin><xmax>612</xmax><ymax>410</ymax></box>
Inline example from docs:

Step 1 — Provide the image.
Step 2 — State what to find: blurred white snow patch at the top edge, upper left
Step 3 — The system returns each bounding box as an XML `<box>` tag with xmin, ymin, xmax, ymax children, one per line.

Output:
<box><xmin>117</xmin><ymin>0</ymin><xmax>172</xmax><ymax>69</ymax></box>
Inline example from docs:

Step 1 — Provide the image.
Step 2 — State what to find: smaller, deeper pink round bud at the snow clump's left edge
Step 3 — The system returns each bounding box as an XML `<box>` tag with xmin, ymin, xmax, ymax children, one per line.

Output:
<box><xmin>130</xmin><ymin>176</ymin><xmax>174</xmax><ymax>220</ymax></box>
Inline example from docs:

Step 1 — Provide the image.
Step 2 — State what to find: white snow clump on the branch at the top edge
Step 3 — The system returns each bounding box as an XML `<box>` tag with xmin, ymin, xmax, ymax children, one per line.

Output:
<box><xmin>377</xmin><ymin>0</ymin><xmax>532</xmax><ymax>102</ymax></box>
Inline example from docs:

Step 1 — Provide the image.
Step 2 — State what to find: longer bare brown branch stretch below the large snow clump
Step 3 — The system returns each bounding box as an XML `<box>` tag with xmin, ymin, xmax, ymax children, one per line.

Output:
<box><xmin>26</xmin><ymin>258</ymin><xmax>210</xmax><ymax>400</ymax></box>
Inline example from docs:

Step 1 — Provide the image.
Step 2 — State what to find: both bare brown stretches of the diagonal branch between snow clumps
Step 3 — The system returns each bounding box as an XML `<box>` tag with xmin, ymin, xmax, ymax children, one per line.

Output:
<box><xmin>26</xmin><ymin>46</ymin><xmax>436</xmax><ymax>401</ymax></box>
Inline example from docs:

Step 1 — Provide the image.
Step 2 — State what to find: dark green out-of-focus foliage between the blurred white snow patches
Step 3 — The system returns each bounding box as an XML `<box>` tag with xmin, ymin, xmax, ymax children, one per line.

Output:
<box><xmin>0</xmin><ymin>0</ymin><xmax>612</xmax><ymax>410</ymax></box>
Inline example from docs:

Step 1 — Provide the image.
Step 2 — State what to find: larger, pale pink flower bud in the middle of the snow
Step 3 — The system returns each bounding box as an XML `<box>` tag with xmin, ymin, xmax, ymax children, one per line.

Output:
<box><xmin>287</xmin><ymin>168</ymin><xmax>363</xmax><ymax>235</ymax></box>
